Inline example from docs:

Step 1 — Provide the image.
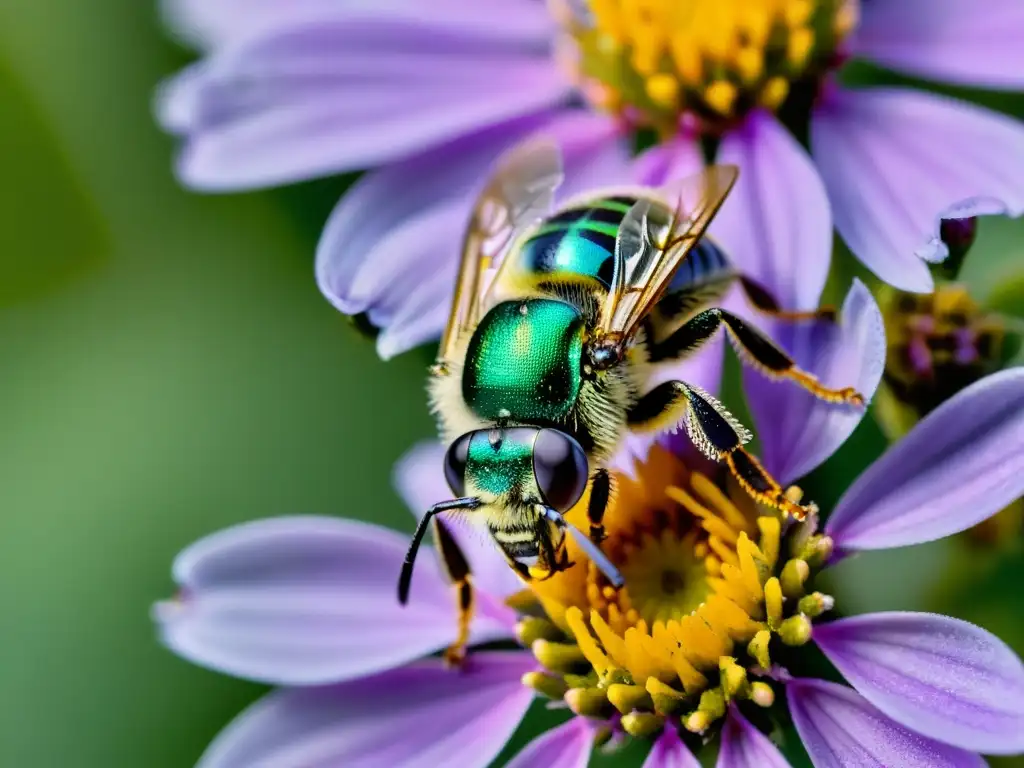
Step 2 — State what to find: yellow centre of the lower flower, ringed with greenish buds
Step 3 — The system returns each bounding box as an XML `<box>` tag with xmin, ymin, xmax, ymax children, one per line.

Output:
<box><xmin>518</xmin><ymin>447</ymin><xmax>831</xmax><ymax>736</ymax></box>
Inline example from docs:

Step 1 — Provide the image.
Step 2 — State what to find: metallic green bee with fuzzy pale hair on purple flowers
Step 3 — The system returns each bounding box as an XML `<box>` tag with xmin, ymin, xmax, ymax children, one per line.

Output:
<box><xmin>398</xmin><ymin>140</ymin><xmax>863</xmax><ymax>660</ymax></box>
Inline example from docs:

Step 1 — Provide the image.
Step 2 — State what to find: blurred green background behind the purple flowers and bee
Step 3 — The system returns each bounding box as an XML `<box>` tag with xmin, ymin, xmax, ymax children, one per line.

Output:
<box><xmin>0</xmin><ymin>0</ymin><xmax>1024</xmax><ymax>768</ymax></box>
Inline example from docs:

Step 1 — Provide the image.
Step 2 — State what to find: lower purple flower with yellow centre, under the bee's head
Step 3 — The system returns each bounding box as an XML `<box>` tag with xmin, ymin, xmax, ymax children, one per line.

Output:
<box><xmin>156</xmin><ymin>370</ymin><xmax>1024</xmax><ymax>768</ymax></box>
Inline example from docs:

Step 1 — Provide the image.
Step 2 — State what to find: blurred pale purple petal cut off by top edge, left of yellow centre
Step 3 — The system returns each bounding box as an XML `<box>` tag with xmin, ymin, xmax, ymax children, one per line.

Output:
<box><xmin>161</xmin><ymin>0</ymin><xmax>553</xmax><ymax>48</ymax></box>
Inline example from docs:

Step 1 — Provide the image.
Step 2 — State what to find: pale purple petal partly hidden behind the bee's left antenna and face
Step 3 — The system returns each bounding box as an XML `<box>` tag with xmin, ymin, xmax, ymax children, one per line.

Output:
<box><xmin>394</xmin><ymin>440</ymin><xmax>523</xmax><ymax>613</ymax></box>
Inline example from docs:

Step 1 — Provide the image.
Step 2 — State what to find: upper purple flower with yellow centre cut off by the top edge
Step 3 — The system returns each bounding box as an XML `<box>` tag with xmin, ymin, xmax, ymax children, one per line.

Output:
<box><xmin>158</xmin><ymin>0</ymin><xmax>1024</xmax><ymax>357</ymax></box>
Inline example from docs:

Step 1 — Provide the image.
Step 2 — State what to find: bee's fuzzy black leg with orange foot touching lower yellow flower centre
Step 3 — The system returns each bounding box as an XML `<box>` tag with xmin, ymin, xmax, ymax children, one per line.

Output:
<box><xmin>629</xmin><ymin>381</ymin><xmax>817</xmax><ymax>520</ymax></box>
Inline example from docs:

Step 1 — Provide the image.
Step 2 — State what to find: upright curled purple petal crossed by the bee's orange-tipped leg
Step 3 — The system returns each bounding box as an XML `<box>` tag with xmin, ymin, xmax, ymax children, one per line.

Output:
<box><xmin>743</xmin><ymin>280</ymin><xmax>886</xmax><ymax>483</ymax></box>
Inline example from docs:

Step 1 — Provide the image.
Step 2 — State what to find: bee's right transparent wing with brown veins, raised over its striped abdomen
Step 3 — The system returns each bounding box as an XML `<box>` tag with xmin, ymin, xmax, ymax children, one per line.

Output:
<box><xmin>600</xmin><ymin>165</ymin><xmax>739</xmax><ymax>339</ymax></box>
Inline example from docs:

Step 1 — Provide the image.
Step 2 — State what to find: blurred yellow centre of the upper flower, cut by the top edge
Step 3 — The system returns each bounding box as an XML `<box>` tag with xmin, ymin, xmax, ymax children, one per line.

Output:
<box><xmin>550</xmin><ymin>0</ymin><xmax>858</xmax><ymax>134</ymax></box>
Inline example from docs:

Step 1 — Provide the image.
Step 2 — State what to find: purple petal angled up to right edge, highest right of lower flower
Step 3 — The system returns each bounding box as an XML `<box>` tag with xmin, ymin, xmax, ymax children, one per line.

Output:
<box><xmin>825</xmin><ymin>368</ymin><xmax>1024</xmax><ymax>550</ymax></box>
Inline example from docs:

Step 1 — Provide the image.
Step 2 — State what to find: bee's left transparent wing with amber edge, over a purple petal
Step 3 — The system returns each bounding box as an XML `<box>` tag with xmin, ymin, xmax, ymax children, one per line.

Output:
<box><xmin>439</xmin><ymin>138</ymin><xmax>564</xmax><ymax>359</ymax></box>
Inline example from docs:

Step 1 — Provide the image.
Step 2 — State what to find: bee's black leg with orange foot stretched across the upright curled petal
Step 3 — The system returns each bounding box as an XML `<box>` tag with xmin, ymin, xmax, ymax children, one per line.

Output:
<box><xmin>649</xmin><ymin>307</ymin><xmax>864</xmax><ymax>406</ymax></box>
